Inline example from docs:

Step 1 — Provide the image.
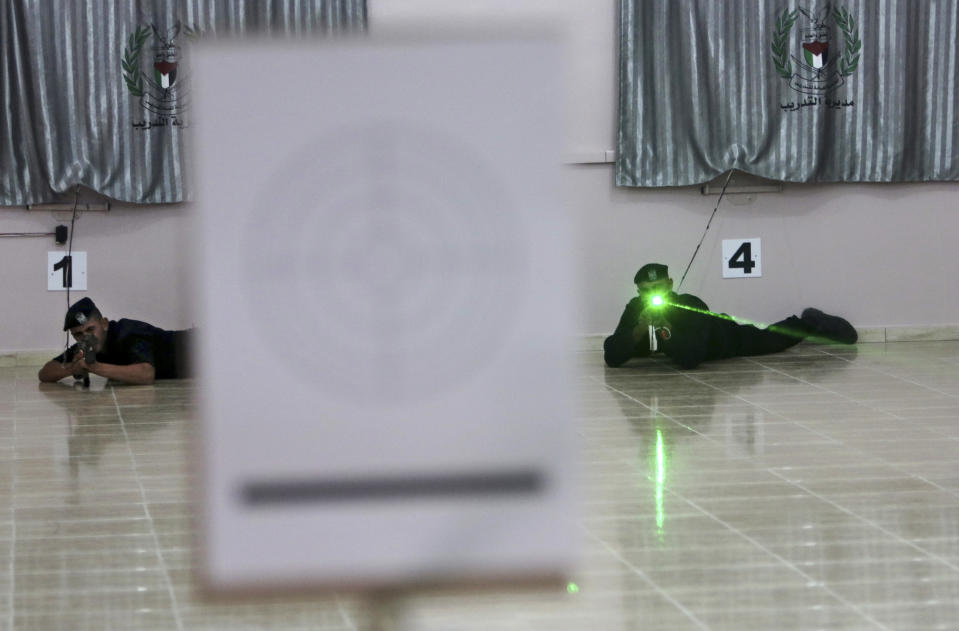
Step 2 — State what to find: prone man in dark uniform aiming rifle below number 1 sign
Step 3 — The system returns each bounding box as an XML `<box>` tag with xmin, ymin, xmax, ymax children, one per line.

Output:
<box><xmin>38</xmin><ymin>298</ymin><xmax>193</xmax><ymax>385</ymax></box>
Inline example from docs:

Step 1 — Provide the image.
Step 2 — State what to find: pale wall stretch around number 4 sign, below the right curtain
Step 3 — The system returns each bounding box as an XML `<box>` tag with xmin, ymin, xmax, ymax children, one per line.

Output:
<box><xmin>570</xmin><ymin>165</ymin><xmax>959</xmax><ymax>333</ymax></box>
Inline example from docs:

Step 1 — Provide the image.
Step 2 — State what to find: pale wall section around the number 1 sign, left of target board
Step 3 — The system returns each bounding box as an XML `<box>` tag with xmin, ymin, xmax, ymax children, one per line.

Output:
<box><xmin>0</xmin><ymin>205</ymin><xmax>193</xmax><ymax>351</ymax></box>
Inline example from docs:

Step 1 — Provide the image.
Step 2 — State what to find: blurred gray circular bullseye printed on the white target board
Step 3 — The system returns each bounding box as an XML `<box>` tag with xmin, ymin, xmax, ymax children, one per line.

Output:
<box><xmin>244</xmin><ymin>122</ymin><xmax>528</xmax><ymax>405</ymax></box>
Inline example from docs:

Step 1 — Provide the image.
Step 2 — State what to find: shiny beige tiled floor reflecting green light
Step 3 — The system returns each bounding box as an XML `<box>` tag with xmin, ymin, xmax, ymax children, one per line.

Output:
<box><xmin>0</xmin><ymin>342</ymin><xmax>959</xmax><ymax>631</ymax></box>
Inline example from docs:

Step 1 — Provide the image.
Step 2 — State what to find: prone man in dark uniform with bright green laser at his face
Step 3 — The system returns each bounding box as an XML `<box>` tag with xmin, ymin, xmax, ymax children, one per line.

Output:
<box><xmin>603</xmin><ymin>263</ymin><xmax>858</xmax><ymax>368</ymax></box>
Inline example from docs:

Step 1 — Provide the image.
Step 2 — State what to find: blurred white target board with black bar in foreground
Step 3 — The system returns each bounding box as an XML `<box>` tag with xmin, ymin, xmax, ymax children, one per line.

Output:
<box><xmin>192</xmin><ymin>34</ymin><xmax>576</xmax><ymax>590</ymax></box>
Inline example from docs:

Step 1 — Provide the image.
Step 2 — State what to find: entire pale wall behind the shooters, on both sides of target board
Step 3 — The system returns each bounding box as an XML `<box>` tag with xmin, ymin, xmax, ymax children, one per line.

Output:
<box><xmin>0</xmin><ymin>0</ymin><xmax>959</xmax><ymax>351</ymax></box>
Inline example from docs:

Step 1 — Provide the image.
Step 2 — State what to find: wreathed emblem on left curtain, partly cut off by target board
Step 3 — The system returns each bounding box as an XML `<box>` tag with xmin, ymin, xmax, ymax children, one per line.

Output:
<box><xmin>120</xmin><ymin>22</ymin><xmax>196</xmax><ymax>130</ymax></box>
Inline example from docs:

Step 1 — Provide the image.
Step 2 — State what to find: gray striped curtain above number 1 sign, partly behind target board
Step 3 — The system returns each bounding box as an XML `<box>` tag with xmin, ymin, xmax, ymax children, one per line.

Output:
<box><xmin>0</xmin><ymin>0</ymin><xmax>367</xmax><ymax>205</ymax></box>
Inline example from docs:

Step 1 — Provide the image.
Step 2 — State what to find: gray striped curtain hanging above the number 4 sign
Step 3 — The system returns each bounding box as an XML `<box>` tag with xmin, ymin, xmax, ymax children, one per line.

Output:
<box><xmin>616</xmin><ymin>0</ymin><xmax>959</xmax><ymax>186</ymax></box>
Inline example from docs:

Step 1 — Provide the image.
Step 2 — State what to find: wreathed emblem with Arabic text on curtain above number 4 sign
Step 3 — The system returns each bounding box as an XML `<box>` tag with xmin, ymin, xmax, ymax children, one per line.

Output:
<box><xmin>771</xmin><ymin>4</ymin><xmax>862</xmax><ymax>110</ymax></box>
